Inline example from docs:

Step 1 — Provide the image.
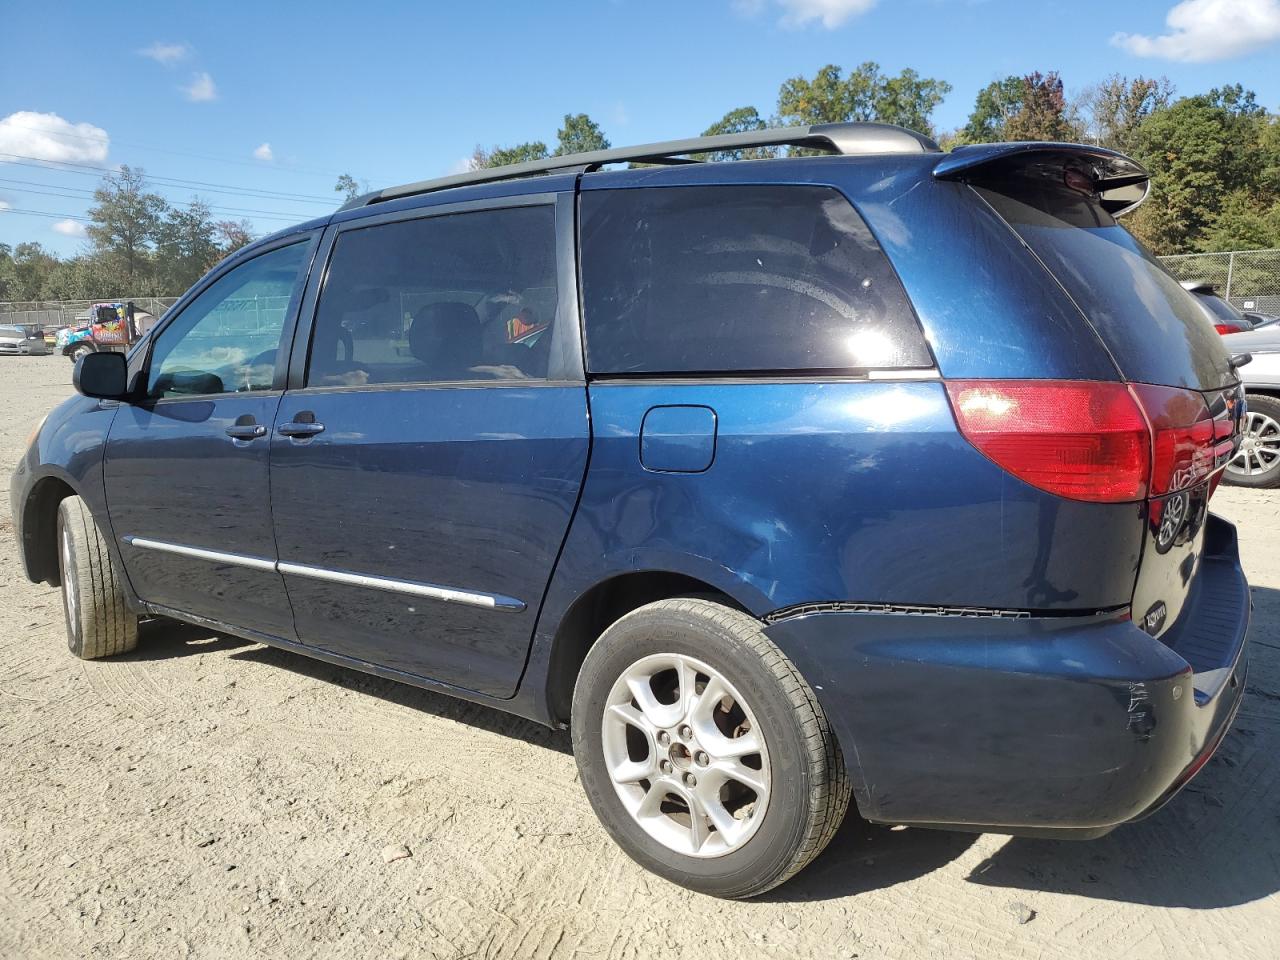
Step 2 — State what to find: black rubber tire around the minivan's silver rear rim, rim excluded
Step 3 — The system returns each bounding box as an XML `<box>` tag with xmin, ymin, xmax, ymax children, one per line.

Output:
<box><xmin>571</xmin><ymin>599</ymin><xmax>849</xmax><ymax>899</ymax></box>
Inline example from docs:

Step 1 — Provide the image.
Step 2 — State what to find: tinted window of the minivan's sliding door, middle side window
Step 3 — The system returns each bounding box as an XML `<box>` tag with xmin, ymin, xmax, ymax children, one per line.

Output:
<box><xmin>307</xmin><ymin>205</ymin><xmax>557</xmax><ymax>387</ymax></box>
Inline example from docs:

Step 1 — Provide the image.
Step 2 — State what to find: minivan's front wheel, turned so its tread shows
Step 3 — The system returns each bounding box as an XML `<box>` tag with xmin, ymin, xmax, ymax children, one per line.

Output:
<box><xmin>58</xmin><ymin>497</ymin><xmax>138</xmax><ymax>660</ymax></box>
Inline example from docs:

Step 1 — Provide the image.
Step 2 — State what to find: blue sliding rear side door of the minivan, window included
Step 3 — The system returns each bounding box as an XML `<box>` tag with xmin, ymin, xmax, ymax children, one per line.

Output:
<box><xmin>271</xmin><ymin>195</ymin><xmax>589</xmax><ymax>696</ymax></box>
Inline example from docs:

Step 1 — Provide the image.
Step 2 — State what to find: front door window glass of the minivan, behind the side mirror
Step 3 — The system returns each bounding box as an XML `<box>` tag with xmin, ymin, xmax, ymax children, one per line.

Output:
<box><xmin>147</xmin><ymin>248</ymin><xmax>310</xmax><ymax>397</ymax></box>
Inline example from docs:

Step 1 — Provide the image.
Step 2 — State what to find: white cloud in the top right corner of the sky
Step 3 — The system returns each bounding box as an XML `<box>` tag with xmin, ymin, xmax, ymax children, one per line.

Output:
<box><xmin>1111</xmin><ymin>0</ymin><xmax>1280</xmax><ymax>63</ymax></box>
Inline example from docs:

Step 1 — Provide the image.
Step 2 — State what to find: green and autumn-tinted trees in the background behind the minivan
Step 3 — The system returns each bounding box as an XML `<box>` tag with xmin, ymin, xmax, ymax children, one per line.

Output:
<box><xmin>0</xmin><ymin>61</ymin><xmax>1280</xmax><ymax>301</ymax></box>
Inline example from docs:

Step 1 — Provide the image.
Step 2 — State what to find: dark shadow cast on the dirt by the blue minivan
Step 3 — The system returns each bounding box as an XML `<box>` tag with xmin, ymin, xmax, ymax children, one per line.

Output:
<box><xmin>123</xmin><ymin>588</ymin><xmax>1280</xmax><ymax>909</ymax></box>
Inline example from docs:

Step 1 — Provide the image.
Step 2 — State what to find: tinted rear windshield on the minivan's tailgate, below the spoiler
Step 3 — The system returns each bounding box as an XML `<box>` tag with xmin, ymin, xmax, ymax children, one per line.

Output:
<box><xmin>975</xmin><ymin>178</ymin><xmax>1235</xmax><ymax>389</ymax></box>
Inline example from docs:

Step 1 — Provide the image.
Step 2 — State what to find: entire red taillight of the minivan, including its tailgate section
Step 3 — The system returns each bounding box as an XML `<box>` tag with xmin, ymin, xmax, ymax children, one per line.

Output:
<box><xmin>947</xmin><ymin>380</ymin><xmax>1231</xmax><ymax>503</ymax></box>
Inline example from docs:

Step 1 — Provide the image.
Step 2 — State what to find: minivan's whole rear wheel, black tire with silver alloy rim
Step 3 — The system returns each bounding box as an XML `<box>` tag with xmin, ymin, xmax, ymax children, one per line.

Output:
<box><xmin>572</xmin><ymin>599</ymin><xmax>849</xmax><ymax>897</ymax></box>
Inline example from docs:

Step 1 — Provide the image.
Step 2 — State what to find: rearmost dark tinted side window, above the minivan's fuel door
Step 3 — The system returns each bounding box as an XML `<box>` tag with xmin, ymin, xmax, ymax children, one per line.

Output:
<box><xmin>581</xmin><ymin>186</ymin><xmax>933</xmax><ymax>374</ymax></box>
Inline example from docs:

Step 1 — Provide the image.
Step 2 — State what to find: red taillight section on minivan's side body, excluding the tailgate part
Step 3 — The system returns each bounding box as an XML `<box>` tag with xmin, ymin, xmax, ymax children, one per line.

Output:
<box><xmin>947</xmin><ymin>380</ymin><xmax>1151</xmax><ymax>503</ymax></box>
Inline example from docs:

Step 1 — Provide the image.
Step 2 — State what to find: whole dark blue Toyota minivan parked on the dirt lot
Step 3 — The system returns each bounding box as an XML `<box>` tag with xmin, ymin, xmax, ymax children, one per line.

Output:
<box><xmin>12</xmin><ymin>124</ymin><xmax>1251</xmax><ymax>897</ymax></box>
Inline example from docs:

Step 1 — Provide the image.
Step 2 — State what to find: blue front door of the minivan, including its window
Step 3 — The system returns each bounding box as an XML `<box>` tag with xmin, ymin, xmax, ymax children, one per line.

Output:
<box><xmin>105</xmin><ymin>236</ymin><xmax>312</xmax><ymax>639</ymax></box>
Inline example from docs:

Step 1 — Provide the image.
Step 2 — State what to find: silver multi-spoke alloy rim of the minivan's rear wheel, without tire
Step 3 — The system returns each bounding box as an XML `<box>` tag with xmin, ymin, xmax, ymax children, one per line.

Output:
<box><xmin>602</xmin><ymin>654</ymin><xmax>771</xmax><ymax>858</ymax></box>
